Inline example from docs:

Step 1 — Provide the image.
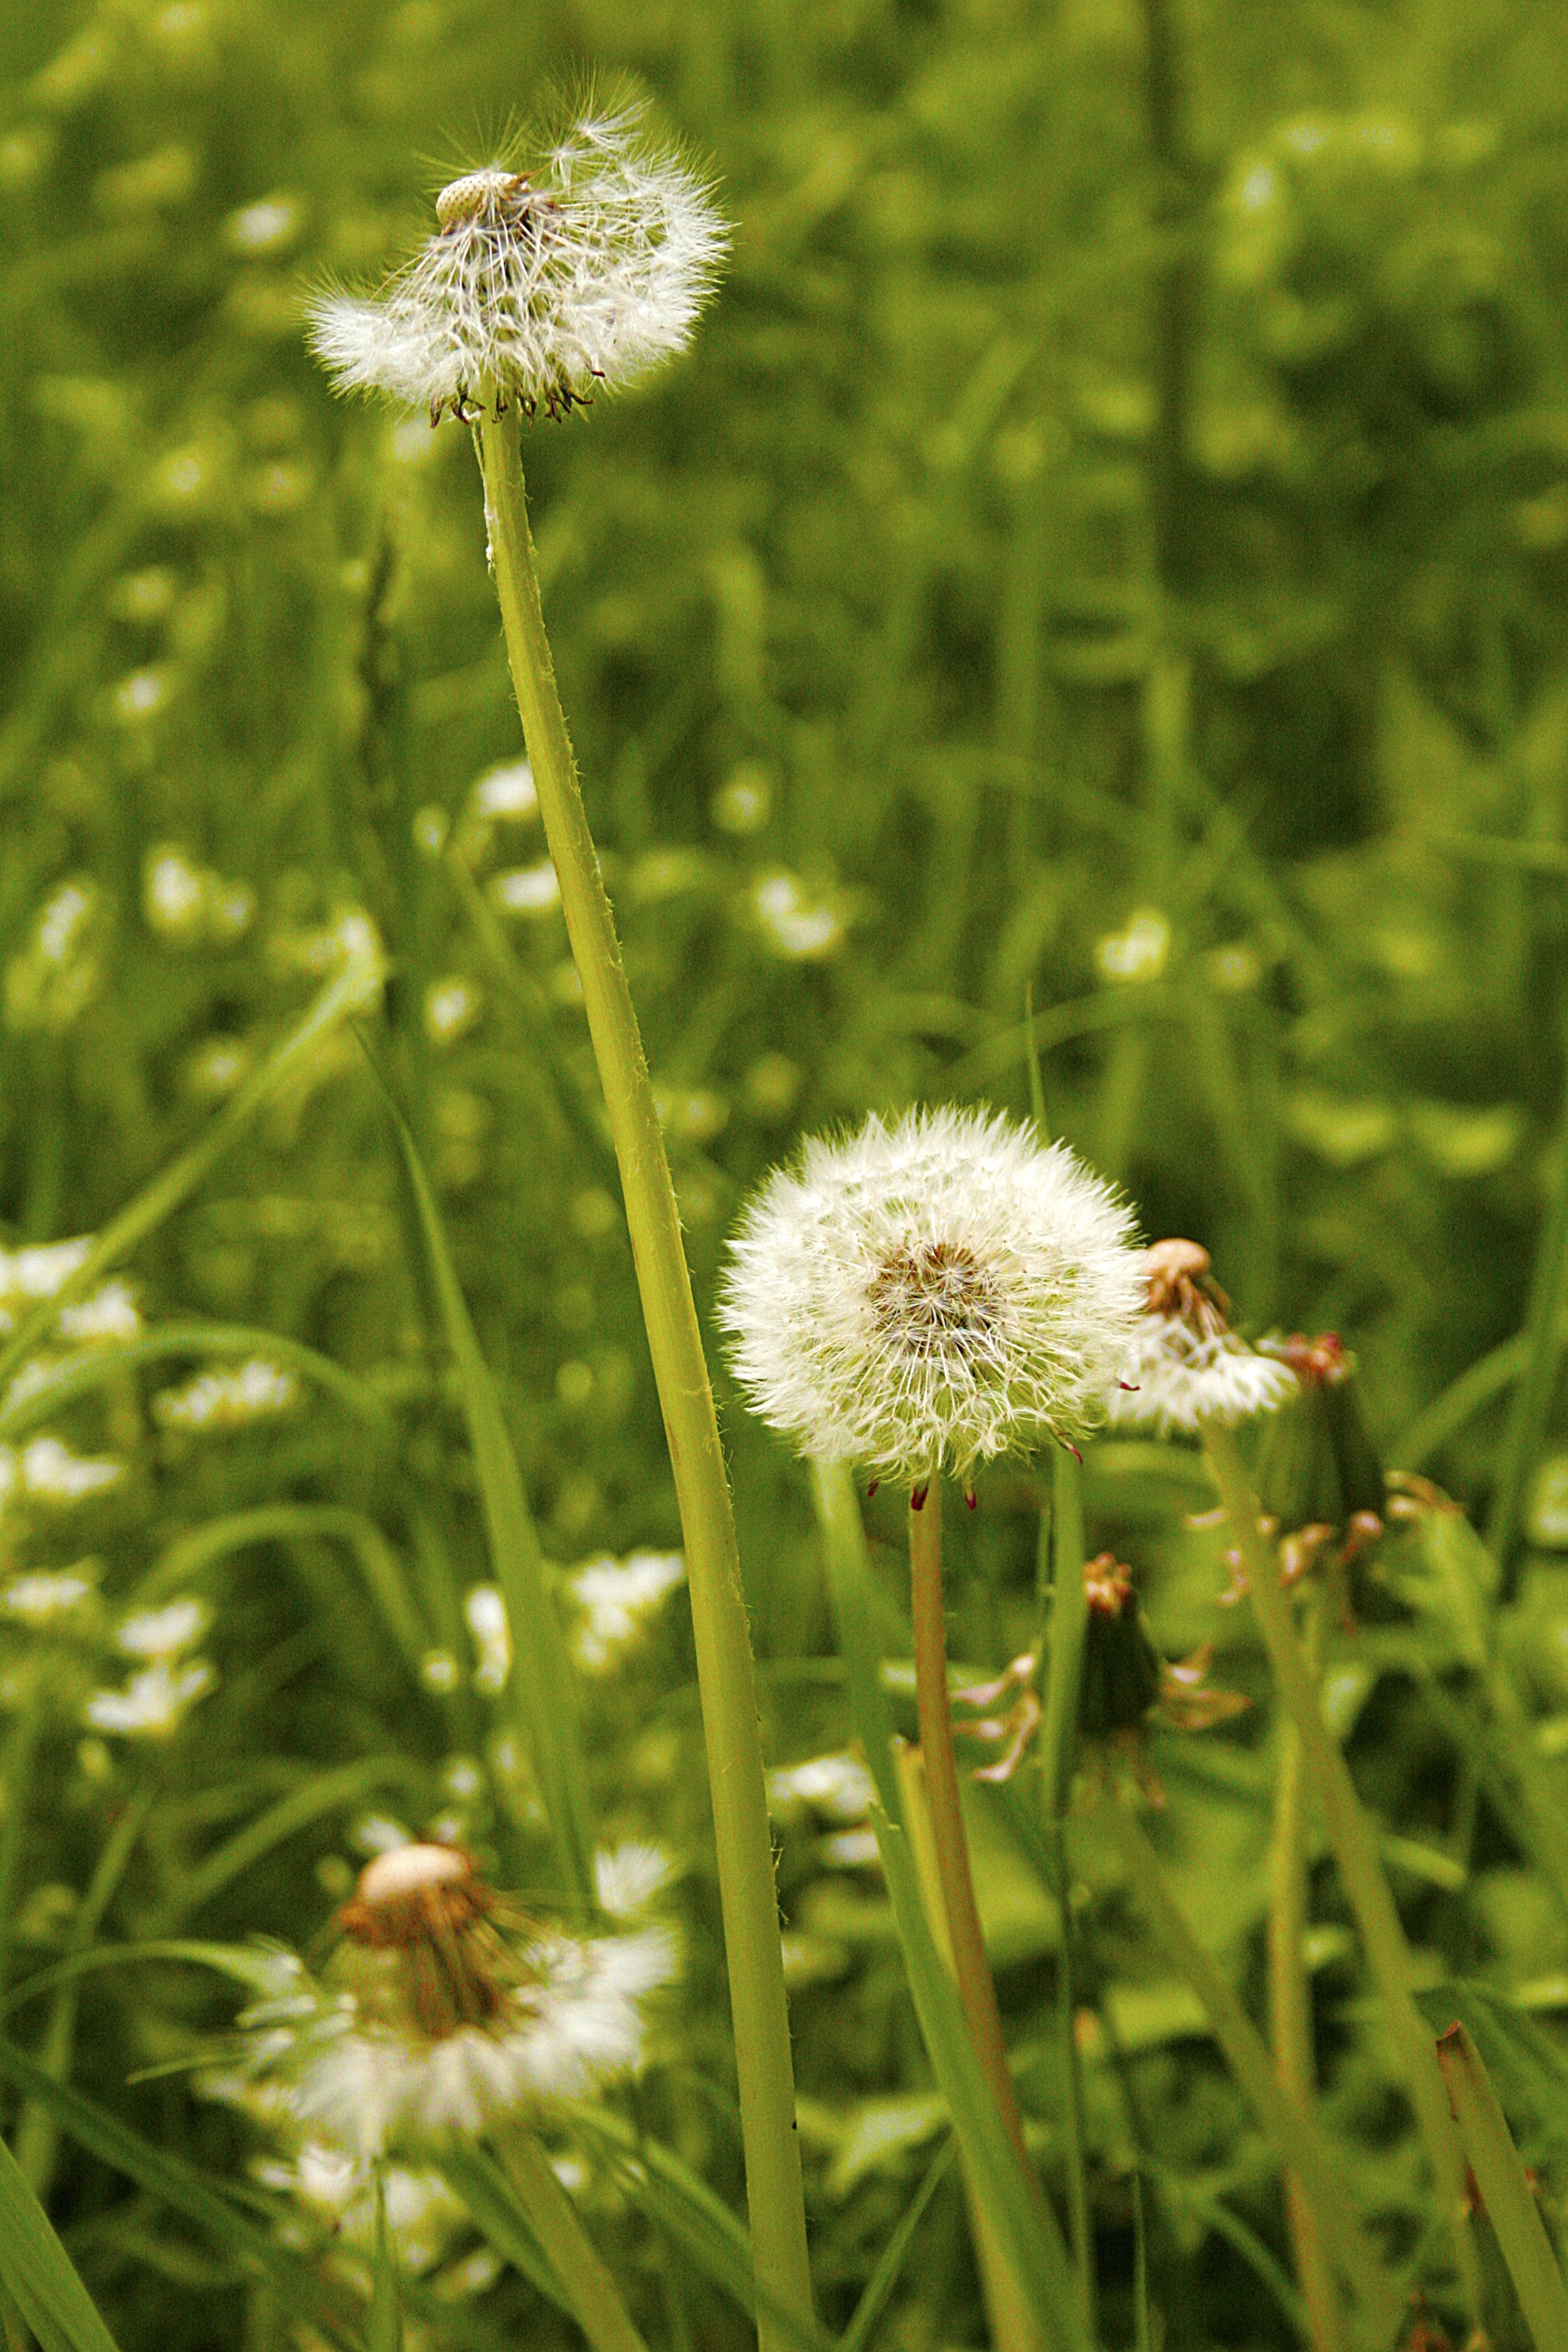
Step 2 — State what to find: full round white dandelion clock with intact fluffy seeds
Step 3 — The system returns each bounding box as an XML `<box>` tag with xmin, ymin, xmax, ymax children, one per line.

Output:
<box><xmin>722</xmin><ymin>1108</ymin><xmax>1143</xmax><ymax>1484</ymax></box>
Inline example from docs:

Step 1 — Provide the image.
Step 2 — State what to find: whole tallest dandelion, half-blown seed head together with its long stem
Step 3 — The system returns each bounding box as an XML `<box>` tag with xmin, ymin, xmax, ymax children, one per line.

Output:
<box><xmin>313</xmin><ymin>113</ymin><xmax>811</xmax><ymax>2352</ymax></box>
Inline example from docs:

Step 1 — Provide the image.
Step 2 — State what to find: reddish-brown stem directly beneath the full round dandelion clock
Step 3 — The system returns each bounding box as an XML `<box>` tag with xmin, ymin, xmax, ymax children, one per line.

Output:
<box><xmin>910</xmin><ymin>1477</ymin><xmax>1027</xmax><ymax>2166</ymax></box>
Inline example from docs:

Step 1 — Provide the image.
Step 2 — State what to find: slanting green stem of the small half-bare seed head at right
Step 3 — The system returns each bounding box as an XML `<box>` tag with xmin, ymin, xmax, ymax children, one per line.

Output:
<box><xmin>1204</xmin><ymin>1423</ymin><xmax>1481</xmax><ymax>2326</ymax></box>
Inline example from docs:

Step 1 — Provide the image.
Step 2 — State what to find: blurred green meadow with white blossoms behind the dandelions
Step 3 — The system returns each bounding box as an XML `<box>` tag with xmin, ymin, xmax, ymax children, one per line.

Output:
<box><xmin>0</xmin><ymin>0</ymin><xmax>1568</xmax><ymax>2352</ymax></box>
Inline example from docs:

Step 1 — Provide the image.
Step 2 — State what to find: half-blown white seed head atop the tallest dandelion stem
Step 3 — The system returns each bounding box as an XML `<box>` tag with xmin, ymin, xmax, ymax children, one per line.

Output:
<box><xmin>310</xmin><ymin>113</ymin><xmax>726</xmax><ymax>423</ymax></box>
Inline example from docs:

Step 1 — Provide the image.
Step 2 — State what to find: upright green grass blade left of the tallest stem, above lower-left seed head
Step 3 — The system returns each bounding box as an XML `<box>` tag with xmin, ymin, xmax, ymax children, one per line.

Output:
<box><xmin>376</xmin><ymin>1067</ymin><xmax>595</xmax><ymax>1907</ymax></box>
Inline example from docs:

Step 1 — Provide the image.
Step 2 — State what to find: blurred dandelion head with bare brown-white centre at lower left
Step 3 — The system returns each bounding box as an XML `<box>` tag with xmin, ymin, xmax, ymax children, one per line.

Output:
<box><xmin>225</xmin><ymin>1846</ymin><xmax>675</xmax><ymax>2161</ymax></box>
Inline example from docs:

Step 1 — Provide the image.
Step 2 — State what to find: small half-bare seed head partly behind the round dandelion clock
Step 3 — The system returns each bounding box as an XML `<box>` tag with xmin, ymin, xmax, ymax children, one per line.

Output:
<box><xmin>1105</xmin><ymin>1242</ymin><xmax>1295</xmax><ymax>1437</ymax></box>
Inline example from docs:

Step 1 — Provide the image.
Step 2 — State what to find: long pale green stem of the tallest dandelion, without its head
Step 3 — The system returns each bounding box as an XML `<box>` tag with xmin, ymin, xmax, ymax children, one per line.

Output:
<box><xmin>477</xmin><ymin>414</ymin><xmax>811</xmax><ymax>2352</ymax></box>
